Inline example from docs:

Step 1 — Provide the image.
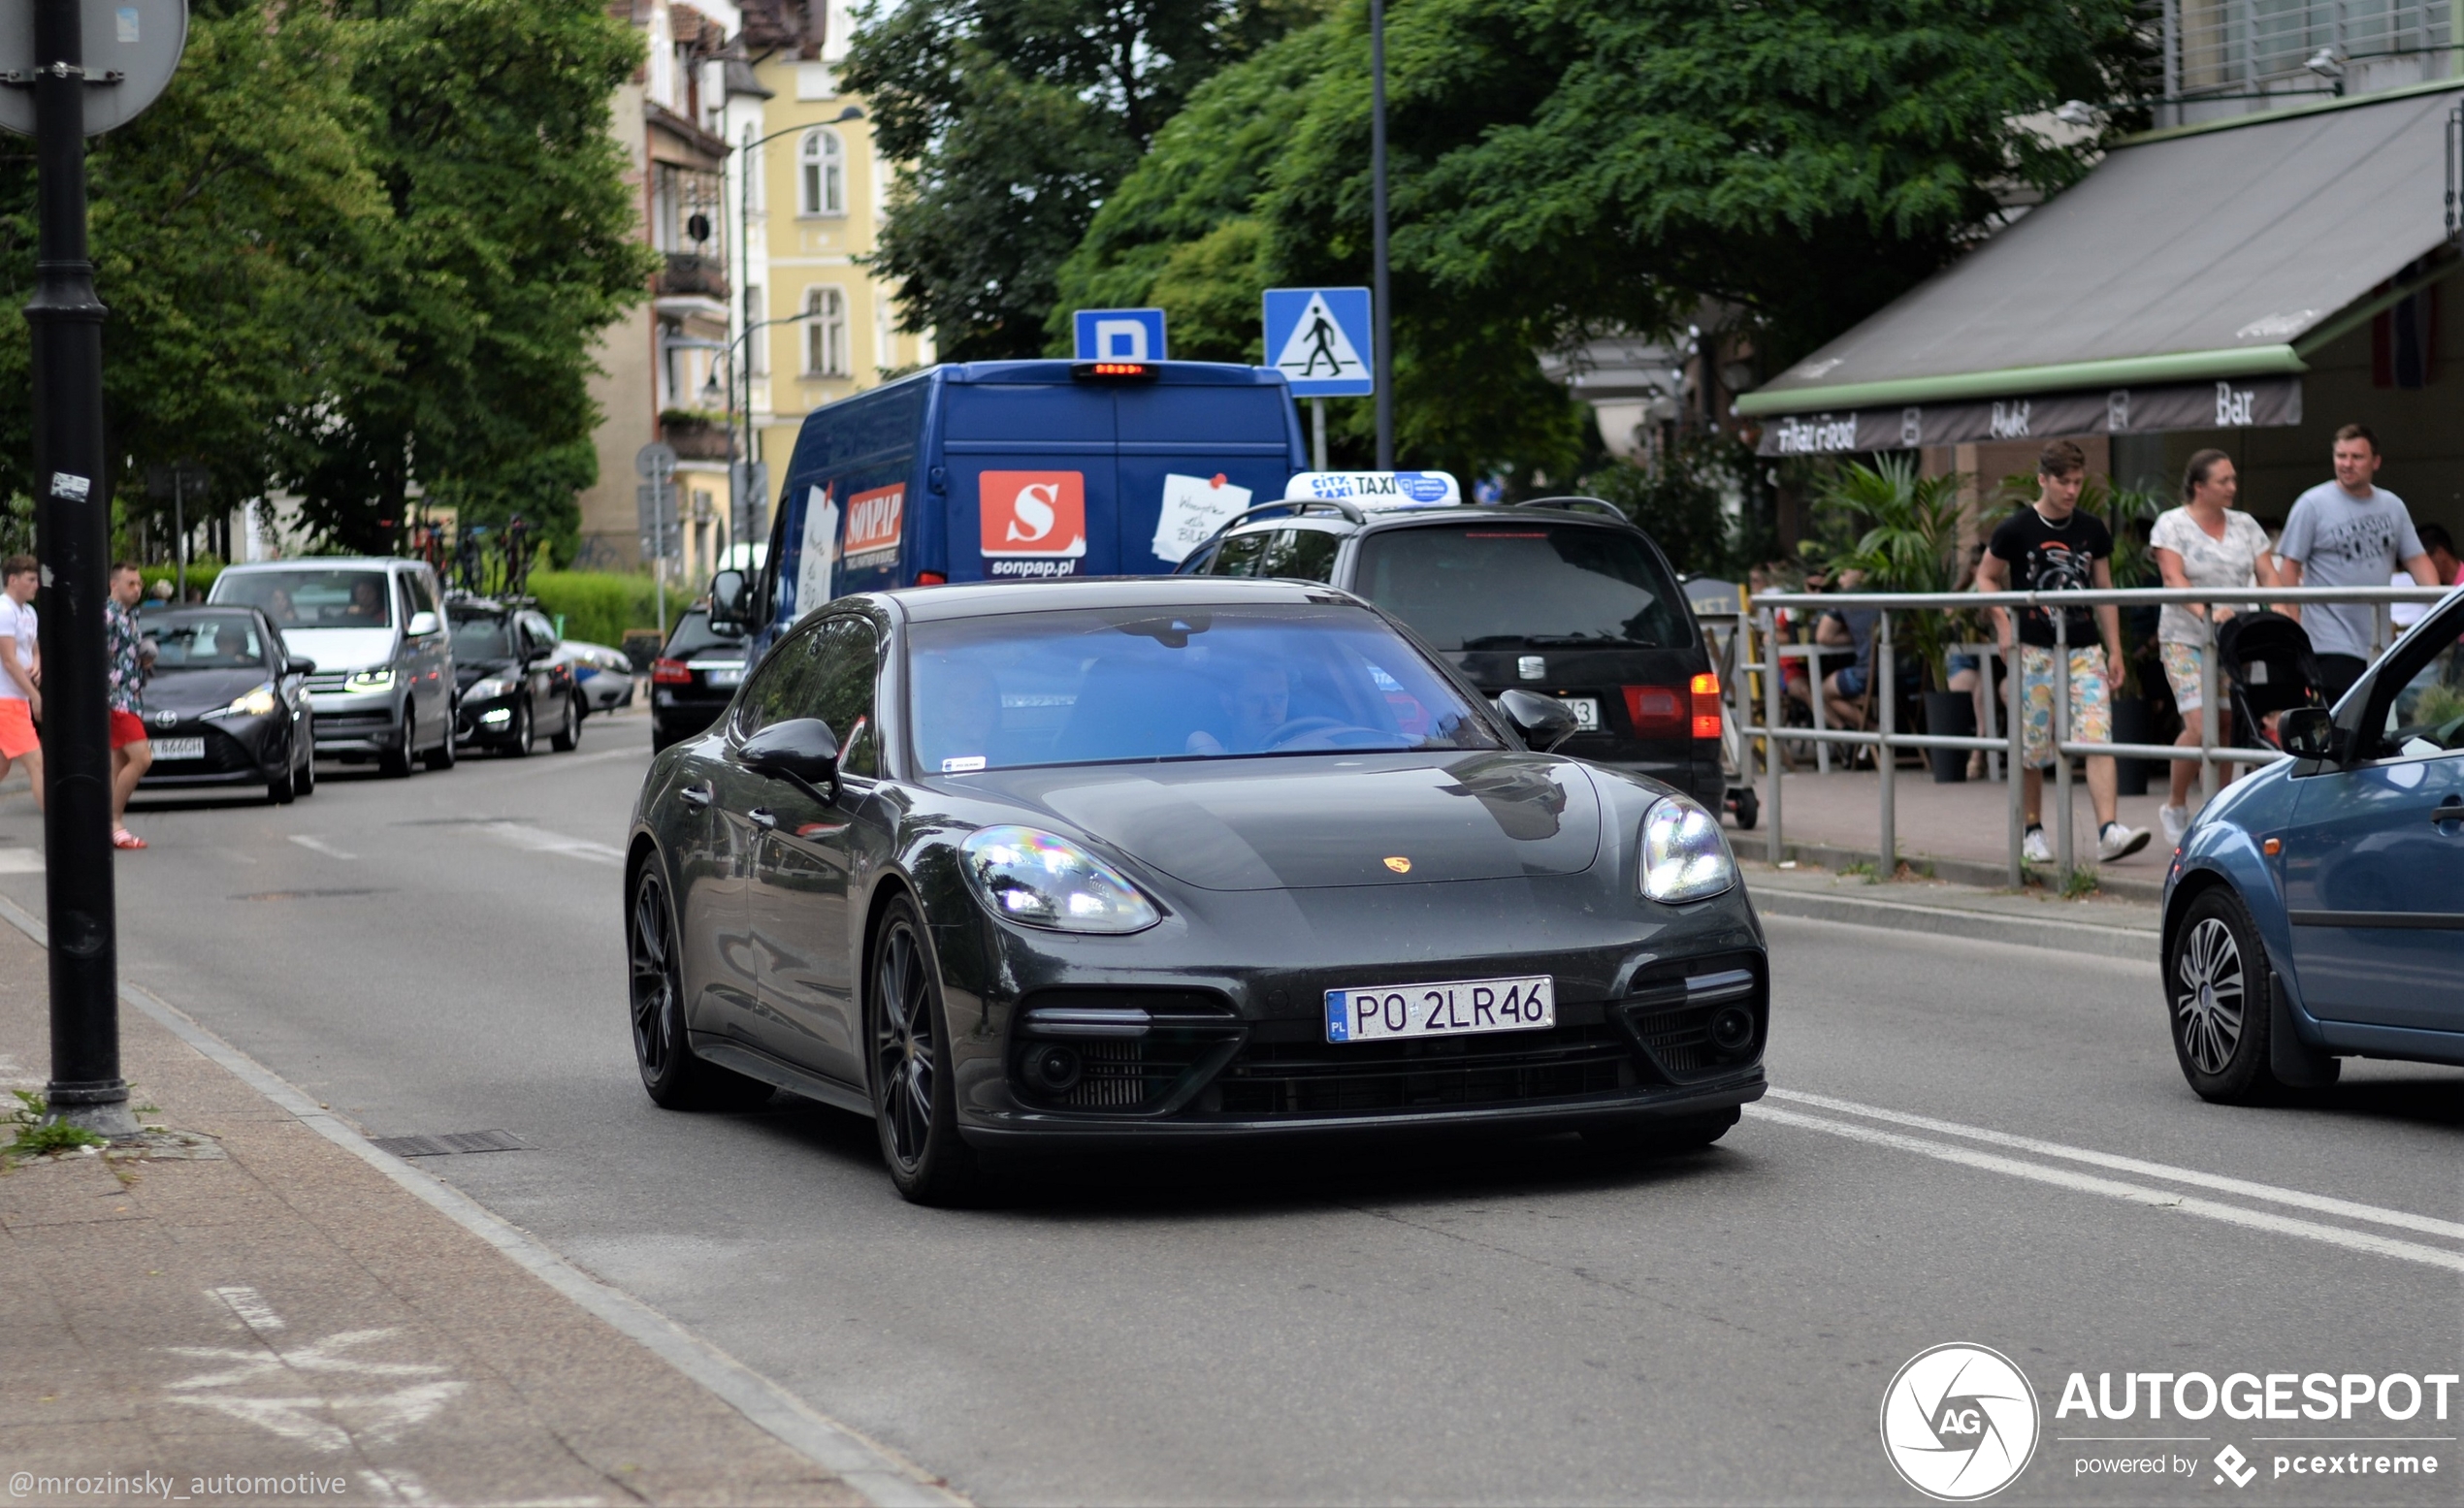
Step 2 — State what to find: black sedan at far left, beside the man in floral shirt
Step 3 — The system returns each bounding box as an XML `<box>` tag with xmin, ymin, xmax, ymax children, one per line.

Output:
<box><xmin>138</xmin><ymin>606</ymin><xmax>315</xmax><ymax>803</ymax></box>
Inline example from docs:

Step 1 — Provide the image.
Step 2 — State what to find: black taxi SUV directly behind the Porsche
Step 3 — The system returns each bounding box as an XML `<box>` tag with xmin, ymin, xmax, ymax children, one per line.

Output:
<box><xmin>1181</xmin><ymin>497</ymin><xmax>1728</xmax><ymax>813</ymax></box>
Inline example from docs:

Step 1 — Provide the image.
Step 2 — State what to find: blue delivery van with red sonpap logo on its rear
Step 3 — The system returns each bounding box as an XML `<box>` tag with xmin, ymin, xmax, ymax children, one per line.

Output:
<box><xmin>747</xmin><ymin>360</ymin><xmax>1306</xmax><ymax>651</ymax></box>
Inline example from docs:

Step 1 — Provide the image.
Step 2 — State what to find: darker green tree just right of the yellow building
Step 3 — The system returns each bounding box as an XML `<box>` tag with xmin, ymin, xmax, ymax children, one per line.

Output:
<box><xmin>845</xmin><ymin>0</ymin><xmax>1313</xmax><ymax>360</ymax></box>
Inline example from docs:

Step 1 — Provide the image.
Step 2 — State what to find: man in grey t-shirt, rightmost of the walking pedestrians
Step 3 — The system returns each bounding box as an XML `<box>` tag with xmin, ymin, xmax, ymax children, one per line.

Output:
<box><xmin>2277</xmin><ymin>424</ymin><xmax>2440</xmax><ymax>702</ymax></box>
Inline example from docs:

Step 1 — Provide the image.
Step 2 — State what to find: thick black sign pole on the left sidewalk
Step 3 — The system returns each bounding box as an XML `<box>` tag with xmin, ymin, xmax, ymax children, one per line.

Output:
<box><xmin>24</xmin><ymin>0</ymin><xmax>138</xmax><ymax>1136</ymax></box>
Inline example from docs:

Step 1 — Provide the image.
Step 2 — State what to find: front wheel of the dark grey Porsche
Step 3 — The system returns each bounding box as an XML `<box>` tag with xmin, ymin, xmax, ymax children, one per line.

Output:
<box><xmin>867</xmin><ymin>897</ymin><xmax>978</xmax><ymax>1204</ymax></box>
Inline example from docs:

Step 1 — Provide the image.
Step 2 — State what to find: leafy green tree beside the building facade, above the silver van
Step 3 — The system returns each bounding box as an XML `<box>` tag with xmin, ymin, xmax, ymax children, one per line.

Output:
<box><xmin>293</xmin><ymin>0</ymin><xmax>651</xmax><ymax>550</ymax></box>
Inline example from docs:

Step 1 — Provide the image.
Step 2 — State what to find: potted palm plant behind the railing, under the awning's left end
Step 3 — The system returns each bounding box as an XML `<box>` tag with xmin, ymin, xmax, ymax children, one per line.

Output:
<box><xmin>1813</xmin><ymin>456</ymin><xmax>1976</xmax><ymax>784</ymax></box>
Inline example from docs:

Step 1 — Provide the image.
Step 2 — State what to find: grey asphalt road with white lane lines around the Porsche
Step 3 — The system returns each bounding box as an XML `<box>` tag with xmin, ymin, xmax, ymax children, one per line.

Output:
<box><xmin>0</xmin><ymin>715</ymin><xmax>2464</xmax><ymax>1503</ymax></box>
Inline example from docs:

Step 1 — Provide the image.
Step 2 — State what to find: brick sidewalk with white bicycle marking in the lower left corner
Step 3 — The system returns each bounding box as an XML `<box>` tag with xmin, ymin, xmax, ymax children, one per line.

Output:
<box><xmin>0</xmin><ymin>907</ymin><xmax>956</xmax><ymax>1508</ymax></box>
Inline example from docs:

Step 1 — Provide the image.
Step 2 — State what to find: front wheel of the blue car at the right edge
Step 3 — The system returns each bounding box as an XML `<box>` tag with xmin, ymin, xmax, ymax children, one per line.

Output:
<box><xmin>2163</xmin><ymin>887</ymin><xmax>2280</xmax><ymax>1104</ymax></box>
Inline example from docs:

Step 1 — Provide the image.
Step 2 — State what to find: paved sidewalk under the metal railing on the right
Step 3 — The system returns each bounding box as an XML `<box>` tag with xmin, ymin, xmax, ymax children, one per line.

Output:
<box><xmin>1728</xmin><ymin>769</ymin><xmax>2198</xmax><ymax>899</ymax></box>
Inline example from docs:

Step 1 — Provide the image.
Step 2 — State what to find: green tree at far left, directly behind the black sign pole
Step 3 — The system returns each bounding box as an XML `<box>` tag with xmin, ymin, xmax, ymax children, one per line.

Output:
<box><xmin>0</xmin><ymin>0</ymin><xmax>392</xmax><ymax>520</ymax></box>
